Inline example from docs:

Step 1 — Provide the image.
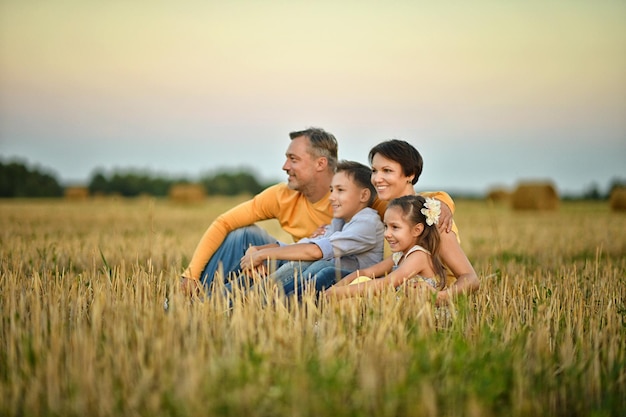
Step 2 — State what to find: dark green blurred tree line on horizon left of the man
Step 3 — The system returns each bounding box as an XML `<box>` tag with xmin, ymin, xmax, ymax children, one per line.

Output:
<box><xmin>0</xmin><ymin>161</ymin><xmax>269</xmax><ymax>198</ymax></box>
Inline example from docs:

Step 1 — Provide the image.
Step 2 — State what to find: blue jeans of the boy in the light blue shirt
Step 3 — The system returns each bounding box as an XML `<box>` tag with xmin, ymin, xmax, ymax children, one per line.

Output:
<box><xmin>272</xmin><ymin>261</ymin><xmax>352</xmax><ymax>297</ymax></box>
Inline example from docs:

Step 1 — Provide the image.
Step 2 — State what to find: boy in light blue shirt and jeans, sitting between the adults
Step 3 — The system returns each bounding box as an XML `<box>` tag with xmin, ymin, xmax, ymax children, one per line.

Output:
<box><xmin>241</xmin><ymin>161</ymin><xmax>384</xmax><ymax>295</ymax></box>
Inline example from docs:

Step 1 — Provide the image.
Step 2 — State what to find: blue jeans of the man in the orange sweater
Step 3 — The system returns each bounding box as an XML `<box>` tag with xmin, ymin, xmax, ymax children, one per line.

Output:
<box><xmin>200</xmin><ymin>225</ymin><xmax>276</xmax><ymax>292</ymax></box>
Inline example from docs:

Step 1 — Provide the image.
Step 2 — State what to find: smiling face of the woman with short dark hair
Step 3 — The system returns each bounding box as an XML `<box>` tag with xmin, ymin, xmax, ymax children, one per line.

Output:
<box><xmin>372</xmin><ymin>153</ymin><xmax>415</xmax><ymax>201</ymax></box>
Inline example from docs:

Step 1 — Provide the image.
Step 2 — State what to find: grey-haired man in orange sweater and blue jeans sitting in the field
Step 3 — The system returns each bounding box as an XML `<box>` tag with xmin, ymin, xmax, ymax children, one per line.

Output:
<box><xmin>182</xmin><ymin>128</ymin><xmax>338</xmax><ymax>291</ymax></box>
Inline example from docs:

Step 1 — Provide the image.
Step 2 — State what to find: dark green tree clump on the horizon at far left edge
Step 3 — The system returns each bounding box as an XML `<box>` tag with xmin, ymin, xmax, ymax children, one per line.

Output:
<box><xmin>0</xmin><ymin>161</ymin><xmax>63</xmax><ymax>198</ymax></box>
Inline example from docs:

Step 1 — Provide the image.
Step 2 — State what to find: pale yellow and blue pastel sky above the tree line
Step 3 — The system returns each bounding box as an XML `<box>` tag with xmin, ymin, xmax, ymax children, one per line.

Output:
<box><xmin>0</xmin><ymin>0</ymin><xmax>626</xmax><ymax>193</ymax></box>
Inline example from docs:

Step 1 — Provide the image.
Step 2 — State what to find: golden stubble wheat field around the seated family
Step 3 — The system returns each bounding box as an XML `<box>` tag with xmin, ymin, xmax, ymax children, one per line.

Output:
<box><xmin>0</xmin><ymin>197</ymin><xmax>626</xmax><ymax>416</ymax></box>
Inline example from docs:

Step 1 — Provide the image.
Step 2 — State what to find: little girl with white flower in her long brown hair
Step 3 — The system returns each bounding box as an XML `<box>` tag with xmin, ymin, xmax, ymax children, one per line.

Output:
<box><xmin>325</xmin><ymin>195</ymin><xmax>446</xmax><ymax>298</ymax></box>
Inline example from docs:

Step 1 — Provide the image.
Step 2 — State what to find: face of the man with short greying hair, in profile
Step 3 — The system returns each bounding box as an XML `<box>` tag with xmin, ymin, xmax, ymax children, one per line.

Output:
<box><xmin>283</xmin><ymin>136</ymin><xmax>317</xmax><ymax>191</ymax></box>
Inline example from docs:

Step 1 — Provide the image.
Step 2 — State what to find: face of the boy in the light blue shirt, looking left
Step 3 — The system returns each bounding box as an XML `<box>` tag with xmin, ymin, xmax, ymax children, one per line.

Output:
<box><xmin>329</xmin><ymin>171</ymin><xmax>369</xmax><ymax>222</ymax></box>
